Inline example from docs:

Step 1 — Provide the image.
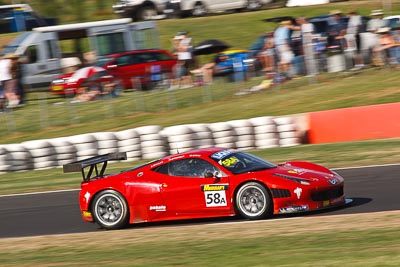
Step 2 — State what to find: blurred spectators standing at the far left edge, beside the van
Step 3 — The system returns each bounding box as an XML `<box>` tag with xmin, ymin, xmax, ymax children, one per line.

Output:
<box><xmin>0</xmin><ymin>54</ymin><xmax>24</xmax><ymax>111</ymax></box>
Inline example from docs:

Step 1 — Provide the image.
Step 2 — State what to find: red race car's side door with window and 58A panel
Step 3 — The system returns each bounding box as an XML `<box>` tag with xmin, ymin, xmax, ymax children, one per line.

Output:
<box><xmin>152</xmin><ymin>158</ymin><xmax>231</xmax><ymax>217</ymax></box>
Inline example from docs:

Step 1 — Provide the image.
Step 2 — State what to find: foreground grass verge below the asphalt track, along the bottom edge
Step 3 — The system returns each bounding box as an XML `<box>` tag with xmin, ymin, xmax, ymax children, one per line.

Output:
<box><xmin>0</xmin><ymin>211</ymin><xmax>400</xmax><ymax>267</ymax></box>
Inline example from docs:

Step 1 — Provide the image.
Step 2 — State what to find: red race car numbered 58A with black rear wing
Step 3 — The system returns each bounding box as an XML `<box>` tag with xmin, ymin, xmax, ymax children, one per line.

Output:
<box><xmin>64</xmin><ymin>148</ymin><xmax>346</xmax><ymax>229</ymax></box>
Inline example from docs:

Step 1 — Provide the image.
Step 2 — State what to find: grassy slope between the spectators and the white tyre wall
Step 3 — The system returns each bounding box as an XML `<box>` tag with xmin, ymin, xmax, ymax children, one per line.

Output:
<box><xmin>0</xmin><ymin>69</ymin><xmax>400</xmax><ymax>143</ymax></box>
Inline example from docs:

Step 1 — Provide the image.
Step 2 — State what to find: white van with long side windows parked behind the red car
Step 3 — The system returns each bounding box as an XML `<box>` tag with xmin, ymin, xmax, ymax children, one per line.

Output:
<box><xmin>2</xmin><ymin>18</ymin><xmax>160</xmax><ymax>88</ymax></box>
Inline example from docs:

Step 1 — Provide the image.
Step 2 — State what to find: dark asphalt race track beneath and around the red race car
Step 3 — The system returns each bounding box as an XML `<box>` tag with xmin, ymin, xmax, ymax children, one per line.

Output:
<box><xmin>0</xmin><ymin>165</ymin><xmax>400</xmax><ymax>238</ymax></box>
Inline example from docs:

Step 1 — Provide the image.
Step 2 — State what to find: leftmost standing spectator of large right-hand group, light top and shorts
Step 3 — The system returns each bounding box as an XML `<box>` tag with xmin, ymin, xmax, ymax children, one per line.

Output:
<box><xmin>274</xmin><ymin>20</ymin><xmax>294</xmax><ymax>74</ymax></box>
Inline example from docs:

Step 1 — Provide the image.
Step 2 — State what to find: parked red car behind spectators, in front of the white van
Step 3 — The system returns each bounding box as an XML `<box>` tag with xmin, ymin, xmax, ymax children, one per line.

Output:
<box><xmin>50</xmin><ymin>49</ymin><xmax>177</xmax><ymax>95</ymax></box>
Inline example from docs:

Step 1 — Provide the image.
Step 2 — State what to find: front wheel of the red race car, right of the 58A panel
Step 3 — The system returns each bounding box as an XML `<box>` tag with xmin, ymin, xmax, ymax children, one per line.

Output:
<box><xmin>235</xmin><ymin>182</ymin><xmax>272</xmax><ymax>220</ymax></box>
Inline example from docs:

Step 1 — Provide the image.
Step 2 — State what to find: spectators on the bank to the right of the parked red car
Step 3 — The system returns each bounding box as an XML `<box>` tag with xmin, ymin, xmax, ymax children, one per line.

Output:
<box><xmin>167</xmin><ymin>10</ymin><xmax>400</xmax><ymax>91</ymax></box>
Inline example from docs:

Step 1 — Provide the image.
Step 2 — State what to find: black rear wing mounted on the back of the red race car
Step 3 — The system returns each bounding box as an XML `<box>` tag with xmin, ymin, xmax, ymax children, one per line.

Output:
<box><xmin>63</xmin><ymin>152</ymin><xmax>127</xmax><ymax>181</ymax></box>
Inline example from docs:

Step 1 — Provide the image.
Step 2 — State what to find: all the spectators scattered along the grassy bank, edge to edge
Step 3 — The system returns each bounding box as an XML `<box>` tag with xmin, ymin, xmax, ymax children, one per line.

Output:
<box><xmin>0</xmin><ymin>10</ymin><xmax>400</xmax><ymax>107</ymax></box>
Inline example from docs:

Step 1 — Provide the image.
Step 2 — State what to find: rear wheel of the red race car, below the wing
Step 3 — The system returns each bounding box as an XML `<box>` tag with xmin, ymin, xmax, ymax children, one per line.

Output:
<box><xmin>92</xmin><ymin>190</ymin><xmax>129</xmax><ymax>230</ymax></box>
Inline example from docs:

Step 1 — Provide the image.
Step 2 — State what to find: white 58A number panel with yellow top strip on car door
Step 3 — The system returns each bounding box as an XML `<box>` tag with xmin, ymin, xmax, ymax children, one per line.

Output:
<box><xmin>201</xmin><ymin>184</ymin><xmax>229</xmax><ymax>208</ymax></box>
